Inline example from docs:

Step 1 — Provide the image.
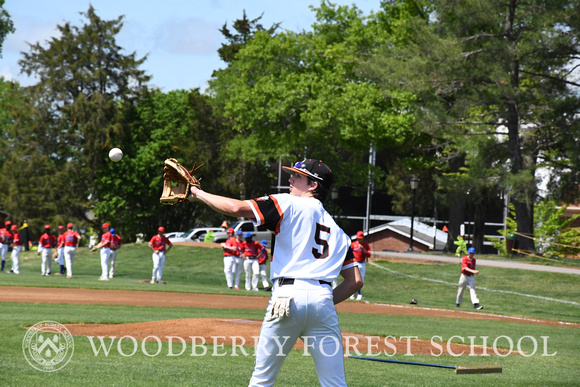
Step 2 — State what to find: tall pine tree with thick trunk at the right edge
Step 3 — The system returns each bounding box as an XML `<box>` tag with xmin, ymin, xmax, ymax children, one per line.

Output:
<box><xmin>366</xmin><ymin>0</ymin><xmax>580</xmax><ymax>250</ymax></box>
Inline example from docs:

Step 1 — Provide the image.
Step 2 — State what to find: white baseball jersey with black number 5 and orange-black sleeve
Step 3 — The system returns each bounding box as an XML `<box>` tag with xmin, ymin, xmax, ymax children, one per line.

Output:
<box><xmin>247</xmin><ymin>194</ymin><xmax>354</xmax><ymax>282</ymax></box>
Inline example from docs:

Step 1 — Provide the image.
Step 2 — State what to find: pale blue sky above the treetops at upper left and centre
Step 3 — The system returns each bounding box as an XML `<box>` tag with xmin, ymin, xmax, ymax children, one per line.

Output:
<box><xmin>0</xmin><ymin>0</ymin><xmax>380</xmax><ymax>91</ymax></box>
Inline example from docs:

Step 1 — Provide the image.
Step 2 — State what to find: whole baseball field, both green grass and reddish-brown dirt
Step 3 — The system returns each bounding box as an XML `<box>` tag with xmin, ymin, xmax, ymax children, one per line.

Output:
<box><xmin>0</xmin><ymin>244</ymin><xmax>580</xmax><ymax>386</ymax></box>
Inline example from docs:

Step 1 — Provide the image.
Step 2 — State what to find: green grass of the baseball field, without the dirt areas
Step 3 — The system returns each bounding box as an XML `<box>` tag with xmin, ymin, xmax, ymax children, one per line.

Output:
<box><xmin>0</xmin><ymin>244</ymin><xmax>580</xmax><ymax>386</ymax></box>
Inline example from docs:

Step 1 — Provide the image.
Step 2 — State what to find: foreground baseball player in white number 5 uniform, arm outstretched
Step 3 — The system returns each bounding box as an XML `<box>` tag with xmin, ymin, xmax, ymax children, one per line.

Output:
<box><xmin>188</xmin><ymin>159</ymin><xmax>363</xmax><ymax>386</ymax></box>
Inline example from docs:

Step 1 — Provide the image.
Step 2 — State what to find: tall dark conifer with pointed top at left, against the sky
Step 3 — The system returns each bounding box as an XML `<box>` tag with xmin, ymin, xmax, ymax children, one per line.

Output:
<box><xmin>2</xmin><ymin>6</ymin><xmax>150</xmax><ymax>233</ymax></box>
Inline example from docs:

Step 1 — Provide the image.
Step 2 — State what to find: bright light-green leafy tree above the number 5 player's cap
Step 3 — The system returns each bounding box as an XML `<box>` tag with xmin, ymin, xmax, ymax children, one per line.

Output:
<box><xmin>210</xmin><ymin>2</ymin><xmax>425</xmax><ymax>203</ymax></box>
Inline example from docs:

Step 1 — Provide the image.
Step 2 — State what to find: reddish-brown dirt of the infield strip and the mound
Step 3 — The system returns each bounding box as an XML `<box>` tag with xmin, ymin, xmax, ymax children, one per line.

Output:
<box><xmin>0</xmin><ymin>286</ymin><xmax>580</xmax><ymax>354</ymax></box>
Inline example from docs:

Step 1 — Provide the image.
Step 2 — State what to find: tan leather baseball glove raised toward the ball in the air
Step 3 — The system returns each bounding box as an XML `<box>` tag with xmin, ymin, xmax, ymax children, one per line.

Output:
<box><xmin>159</xmin><ymin>158</ymin><xmax>203</xmax><ymax>205</ymax></box>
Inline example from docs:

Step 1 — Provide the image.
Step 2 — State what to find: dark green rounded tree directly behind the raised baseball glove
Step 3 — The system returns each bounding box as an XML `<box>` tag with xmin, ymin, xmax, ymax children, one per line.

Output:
<box><xmin>95</xmin><ymin>89</ymin><xmax>231</xmax><ymax>236</ymax></box>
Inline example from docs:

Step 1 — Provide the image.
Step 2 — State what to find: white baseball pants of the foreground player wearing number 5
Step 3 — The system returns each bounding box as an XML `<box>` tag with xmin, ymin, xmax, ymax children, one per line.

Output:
<box><xmin>250</xmin><ymin>279</ymin><xmax>346</xmax><ymax>387</ymax></box>
